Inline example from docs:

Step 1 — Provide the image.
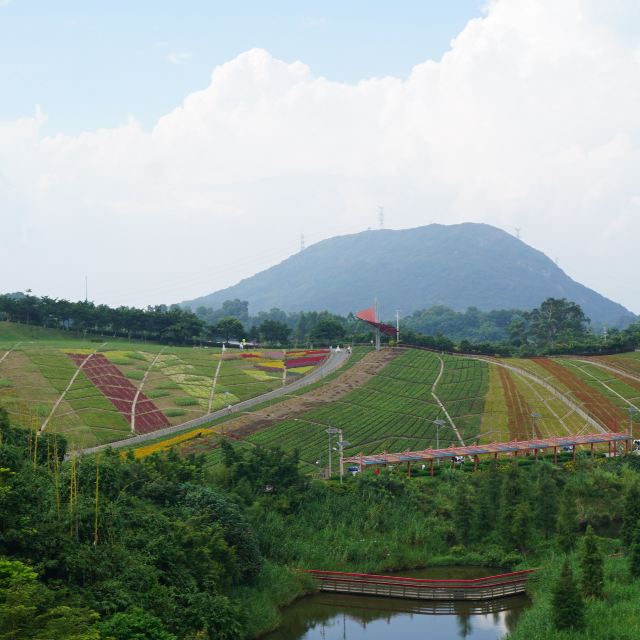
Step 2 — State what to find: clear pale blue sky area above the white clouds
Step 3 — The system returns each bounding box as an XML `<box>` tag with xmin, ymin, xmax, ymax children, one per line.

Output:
<box><xmin>0</xmin><ymin>0</ymin><xmax>485</xmax><ymax>133</ymax></box>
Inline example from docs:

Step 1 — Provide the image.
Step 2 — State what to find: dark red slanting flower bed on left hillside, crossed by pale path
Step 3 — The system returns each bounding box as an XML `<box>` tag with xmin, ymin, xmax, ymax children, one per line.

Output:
<box><xmin>69</xmin><ymin>353</ymin><xmax>170</xmax><ymax>433</ymax></box>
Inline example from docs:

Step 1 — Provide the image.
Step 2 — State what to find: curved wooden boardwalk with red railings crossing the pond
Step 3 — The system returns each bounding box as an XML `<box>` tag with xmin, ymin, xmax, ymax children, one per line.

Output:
<box><xmin>309</xmin><ymin>569</ymin><xmax>535</xmax><ymax>600</ymax></box>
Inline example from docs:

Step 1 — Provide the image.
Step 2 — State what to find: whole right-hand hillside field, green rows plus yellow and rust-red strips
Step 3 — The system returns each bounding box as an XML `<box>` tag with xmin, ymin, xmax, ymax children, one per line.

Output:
<box><xmin>206</xmin><ymin>349</ymin><xmax>640</xmax><ymax>468</ymax></box>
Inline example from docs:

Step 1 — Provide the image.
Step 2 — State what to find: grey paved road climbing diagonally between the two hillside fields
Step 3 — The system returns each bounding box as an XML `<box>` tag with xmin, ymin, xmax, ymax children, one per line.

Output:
<box><xmin>76</xmin><ymin>349</ymin><xmax>349</xmax><ymax>455</ymax></box>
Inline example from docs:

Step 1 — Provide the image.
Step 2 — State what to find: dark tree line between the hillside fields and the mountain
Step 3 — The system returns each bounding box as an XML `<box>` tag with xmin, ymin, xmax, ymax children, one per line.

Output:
<box><xmin>0</xmin><ymin>293</ymin><xmax>640</xmax><ymax>357</ymax></box>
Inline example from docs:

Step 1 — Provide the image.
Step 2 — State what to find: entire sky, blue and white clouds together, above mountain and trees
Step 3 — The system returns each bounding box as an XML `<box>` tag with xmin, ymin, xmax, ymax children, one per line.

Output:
<box><xmin>0</xmin><ymin>0</ymin><xmax>640</xmax><ymax>313</ymax></box>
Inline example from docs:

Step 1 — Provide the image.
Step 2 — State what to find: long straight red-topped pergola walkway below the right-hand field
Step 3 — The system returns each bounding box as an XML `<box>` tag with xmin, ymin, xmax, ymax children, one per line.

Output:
<box><xmin>344</xmin><ymin>431</ymin><xmax>632</xmax><ymax>475</ymax></box>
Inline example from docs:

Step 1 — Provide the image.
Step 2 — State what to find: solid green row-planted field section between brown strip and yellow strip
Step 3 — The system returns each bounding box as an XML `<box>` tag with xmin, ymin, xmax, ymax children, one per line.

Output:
<box><xmin>248</xmin><ymin>350</ymin><xmax>488</xmax><ymax>465</ymax></box>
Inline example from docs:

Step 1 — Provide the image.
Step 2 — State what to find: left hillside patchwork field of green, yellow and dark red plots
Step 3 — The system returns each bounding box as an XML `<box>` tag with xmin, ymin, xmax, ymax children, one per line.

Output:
<box><xmin>0</xmin><ymin>323</ymin><xmax>326</xmax><ymax>447</ymax></box>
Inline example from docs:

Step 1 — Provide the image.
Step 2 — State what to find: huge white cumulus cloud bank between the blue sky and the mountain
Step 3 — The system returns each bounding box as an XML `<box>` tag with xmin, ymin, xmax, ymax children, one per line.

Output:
<box><xmin>0</xmin><ymin>0</ymin><xmax>640</xmax><ymax>312</ymax></box>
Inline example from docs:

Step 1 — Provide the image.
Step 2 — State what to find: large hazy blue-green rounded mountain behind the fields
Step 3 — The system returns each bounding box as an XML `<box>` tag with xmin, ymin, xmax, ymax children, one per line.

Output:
<box><xmin>182</xmin><ymin>223</ymin><xmax>635</xmax><ymax>326</ymax></box>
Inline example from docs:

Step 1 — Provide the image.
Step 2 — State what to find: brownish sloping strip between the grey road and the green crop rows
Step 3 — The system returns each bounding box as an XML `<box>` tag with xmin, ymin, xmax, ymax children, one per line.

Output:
<box><xmin>183</xmin><ymin>349</ymin><xmax>402</xmax><ymax>452</ymax></box>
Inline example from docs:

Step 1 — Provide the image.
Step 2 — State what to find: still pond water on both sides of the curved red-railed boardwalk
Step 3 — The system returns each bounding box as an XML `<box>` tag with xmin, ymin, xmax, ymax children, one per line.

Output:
<box><xmin>265</xmin><ymin>567</ymin><xmax>529</xmax><ymax>640</ymax></box>
